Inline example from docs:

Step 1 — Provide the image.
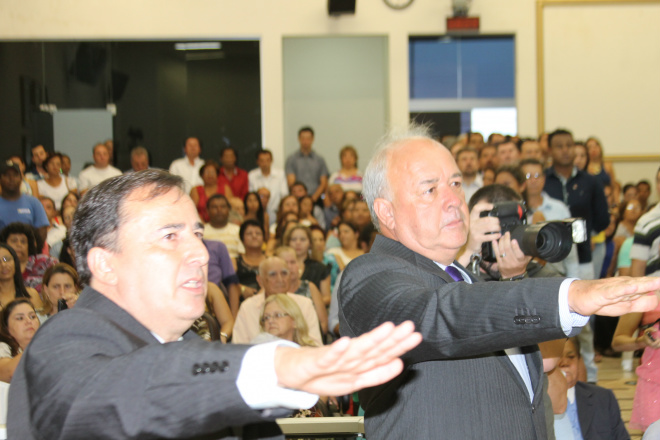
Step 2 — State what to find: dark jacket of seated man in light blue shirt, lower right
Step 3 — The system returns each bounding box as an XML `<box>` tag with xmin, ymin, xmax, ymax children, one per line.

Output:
<box><xmin>575</xmin><ymin>382</ymin><xmax>630</xmax><ymax>440</ymax></box>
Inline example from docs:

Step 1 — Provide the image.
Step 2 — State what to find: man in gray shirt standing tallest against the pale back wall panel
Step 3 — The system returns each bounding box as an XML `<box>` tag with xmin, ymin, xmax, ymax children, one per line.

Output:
<box><xmin>285</xmin><ymin>127</ymin><xmax>329</xmax><ymax>203</ymax></box>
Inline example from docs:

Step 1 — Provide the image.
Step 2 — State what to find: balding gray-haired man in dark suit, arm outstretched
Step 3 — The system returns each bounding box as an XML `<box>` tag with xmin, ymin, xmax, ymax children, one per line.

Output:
<box><xmin>339</xmin><ymin>124</ymin><xmax>660</xmax><ymax>440</ymax></box>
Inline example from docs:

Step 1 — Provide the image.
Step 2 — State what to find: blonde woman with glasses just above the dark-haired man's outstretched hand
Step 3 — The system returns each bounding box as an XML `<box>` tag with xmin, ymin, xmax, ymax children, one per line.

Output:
<box><xmin>251</xmin><ymin>293</ymin><xmax>318</xmax><ymax>347</ymax></box>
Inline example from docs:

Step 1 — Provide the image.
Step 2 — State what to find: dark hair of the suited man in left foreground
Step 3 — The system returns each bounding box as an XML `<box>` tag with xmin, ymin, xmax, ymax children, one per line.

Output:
<box><xmin>71</xmin><ymin>169</ymin><xmax>184</xmax><ymax>284</ymax></box>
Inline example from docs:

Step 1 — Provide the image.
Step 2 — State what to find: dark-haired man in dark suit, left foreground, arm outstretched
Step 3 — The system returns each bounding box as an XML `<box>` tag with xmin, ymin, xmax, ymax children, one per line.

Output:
<box><xmin>8</xmin><ymin>170</ymin><xmax>420</xmax><ymax>440</ymax></box>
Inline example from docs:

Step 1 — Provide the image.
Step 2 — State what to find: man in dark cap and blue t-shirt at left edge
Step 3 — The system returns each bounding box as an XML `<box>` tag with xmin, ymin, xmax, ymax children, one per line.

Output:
<box><xmin>0</xmin><ymin>160</ymin><xmax>50</xmax><ymax>240</ymax></box>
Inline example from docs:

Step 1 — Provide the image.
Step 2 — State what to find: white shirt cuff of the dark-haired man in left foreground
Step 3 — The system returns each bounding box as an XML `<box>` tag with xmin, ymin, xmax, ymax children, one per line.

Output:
<box><xmin>236</xmin><ymin>341</ymin><xmax>319</xmax><ymax>410</ymax></box>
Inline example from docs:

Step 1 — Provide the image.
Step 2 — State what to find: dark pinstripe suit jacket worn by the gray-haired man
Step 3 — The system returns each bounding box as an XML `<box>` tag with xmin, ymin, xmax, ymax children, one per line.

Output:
<box><xmin>339</xmin><ymin>236</ymin><xmax>577</xmax><ymax>440</ymax></box>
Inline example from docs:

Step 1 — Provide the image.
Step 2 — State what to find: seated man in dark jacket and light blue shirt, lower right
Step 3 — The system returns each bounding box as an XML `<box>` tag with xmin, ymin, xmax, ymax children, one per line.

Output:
<box><xmin>555</xmin><ymin>338</ymin><xmax>630</xmax><ymax>440</ymax></box>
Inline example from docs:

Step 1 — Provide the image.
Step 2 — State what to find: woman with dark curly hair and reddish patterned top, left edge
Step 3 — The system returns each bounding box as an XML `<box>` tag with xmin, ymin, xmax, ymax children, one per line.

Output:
<box><xmin>0</xmin><ymin>223</ymin><xmax>59</xmax><ymax>292</ymax></box>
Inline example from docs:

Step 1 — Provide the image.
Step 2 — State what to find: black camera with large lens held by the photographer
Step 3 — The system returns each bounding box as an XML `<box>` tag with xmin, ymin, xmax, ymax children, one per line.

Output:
<box><xmin>481</xmin><ymin>202</ymin><xmax>587</xmax><ymax>263</ymax></box>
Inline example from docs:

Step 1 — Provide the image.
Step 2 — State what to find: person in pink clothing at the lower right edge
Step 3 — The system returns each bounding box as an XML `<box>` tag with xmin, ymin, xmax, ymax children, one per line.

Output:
<box><xmin>612</xmin><ymin>304</ymin><xmax>660</xmax><ymax>431</ymax></box>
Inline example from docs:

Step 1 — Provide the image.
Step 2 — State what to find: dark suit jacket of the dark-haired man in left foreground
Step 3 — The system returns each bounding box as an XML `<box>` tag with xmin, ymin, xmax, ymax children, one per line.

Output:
<box><xmin>8</xmin><ymin>287</ymin><xmax>289</xmax><ymax>440</ymax></box>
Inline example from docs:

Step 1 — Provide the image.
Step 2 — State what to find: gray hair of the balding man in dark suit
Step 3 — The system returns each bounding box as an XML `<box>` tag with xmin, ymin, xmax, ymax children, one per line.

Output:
<box><xmin>362</xmin><ymin>123</ymin><xmax>441</xmax><ymax>231</ymax></box>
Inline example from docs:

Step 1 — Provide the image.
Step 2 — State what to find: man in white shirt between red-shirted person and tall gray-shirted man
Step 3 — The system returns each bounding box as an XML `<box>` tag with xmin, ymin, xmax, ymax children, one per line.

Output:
<box><xmin>248</xmin><ymin>150</ymin><xmax>289</xmax><ymax>224</ymax></box>
